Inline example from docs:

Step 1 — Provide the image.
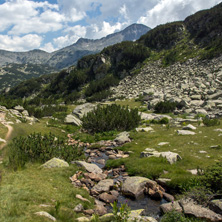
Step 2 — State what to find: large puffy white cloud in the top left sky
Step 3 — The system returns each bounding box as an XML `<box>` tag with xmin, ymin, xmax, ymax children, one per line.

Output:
<box><xmin>0</xmin><ymin>0</ymin><xmax>83</xmax><ymax>35</ymax></box>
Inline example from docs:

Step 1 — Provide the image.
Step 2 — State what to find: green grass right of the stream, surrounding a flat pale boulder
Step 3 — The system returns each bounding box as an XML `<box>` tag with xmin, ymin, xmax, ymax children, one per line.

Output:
<box><xmin>107</xmin><ymin>121</ymin><xmax>222</xmax><ymax>191</ymax></box>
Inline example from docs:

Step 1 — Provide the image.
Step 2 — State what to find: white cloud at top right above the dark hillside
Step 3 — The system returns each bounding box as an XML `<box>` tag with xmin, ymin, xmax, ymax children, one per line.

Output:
<box><xmin>138</xmin><ymin>0</ymin><xmax>221</xmax><ymax>28</ymax></box>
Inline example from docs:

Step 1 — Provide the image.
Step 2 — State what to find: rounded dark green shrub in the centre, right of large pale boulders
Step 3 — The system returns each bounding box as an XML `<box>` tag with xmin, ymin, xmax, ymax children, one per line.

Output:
<box><xmin>82</xmin><ymin>104</ymin><xmax>141</xmax><ymax>133</ymax></box>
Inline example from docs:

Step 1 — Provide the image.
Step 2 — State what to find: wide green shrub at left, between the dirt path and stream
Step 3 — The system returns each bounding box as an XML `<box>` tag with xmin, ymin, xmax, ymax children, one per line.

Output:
<box><xmin>8</xmin><ymin>133</ymin><xmax>83</xmax><ymax>170</ymax></box>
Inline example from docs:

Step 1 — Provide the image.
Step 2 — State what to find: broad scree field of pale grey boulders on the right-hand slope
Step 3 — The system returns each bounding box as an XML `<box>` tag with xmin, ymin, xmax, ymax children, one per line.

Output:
<box><xmin>111</xmin><ymin>56</ymin><xmax>222</xmax><ymax>117</ymax></box>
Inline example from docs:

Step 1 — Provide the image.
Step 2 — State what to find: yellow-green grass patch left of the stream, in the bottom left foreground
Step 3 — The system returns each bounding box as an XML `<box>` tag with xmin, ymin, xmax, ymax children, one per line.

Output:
<box><xmin>0</xmin><ymin>164</ymin><xmax>93</xmax><ymax>222</ymax></box>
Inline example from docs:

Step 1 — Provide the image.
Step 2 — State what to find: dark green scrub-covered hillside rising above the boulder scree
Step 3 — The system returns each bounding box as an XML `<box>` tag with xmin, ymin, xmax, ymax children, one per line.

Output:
<box><xmin>6</xmin><ymin>3</ymin><xmax>222</xmax><ymax>102</ymax></box>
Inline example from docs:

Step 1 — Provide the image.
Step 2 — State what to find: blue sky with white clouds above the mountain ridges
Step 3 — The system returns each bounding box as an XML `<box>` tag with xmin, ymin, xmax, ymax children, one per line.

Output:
<box><xmin>0</xmin><ymin>0</ymin><xmax>221</xmax><ymax>52</ymax></box>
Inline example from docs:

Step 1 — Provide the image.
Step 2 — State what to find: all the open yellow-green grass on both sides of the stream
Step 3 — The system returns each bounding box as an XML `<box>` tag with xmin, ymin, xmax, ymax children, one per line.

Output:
<box><xmin>0</xmin><ymin>100</ymin><xmax>222</xmax><ymax>222</ymax></box>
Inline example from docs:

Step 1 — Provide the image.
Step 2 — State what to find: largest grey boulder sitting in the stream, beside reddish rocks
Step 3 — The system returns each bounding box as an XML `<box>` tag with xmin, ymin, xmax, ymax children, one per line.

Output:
<box><xmin>122</xmin><ymin>176</ymin><xmax>155</xmax><ymax>199</ymax></box>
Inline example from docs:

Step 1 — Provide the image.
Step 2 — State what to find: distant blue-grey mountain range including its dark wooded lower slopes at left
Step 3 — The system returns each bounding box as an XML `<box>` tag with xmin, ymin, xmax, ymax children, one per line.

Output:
<box><xmin>0</xmin><ymin>24</ymin><xmax>150</xmax><ymax>91</ymax></box>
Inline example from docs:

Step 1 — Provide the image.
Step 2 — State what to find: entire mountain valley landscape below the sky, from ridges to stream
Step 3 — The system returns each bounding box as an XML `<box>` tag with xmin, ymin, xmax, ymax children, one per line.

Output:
<box><xmin>0</xmin><ymin>3</ymin><xmax>222</xmax><ymax>222</ymax></box>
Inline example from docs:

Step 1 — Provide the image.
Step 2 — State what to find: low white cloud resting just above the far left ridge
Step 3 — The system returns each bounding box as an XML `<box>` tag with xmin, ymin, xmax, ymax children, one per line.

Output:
<box><xmin>0</xmin><ymin>34</ymin><xmax>43</xmax><ymax>51</ymax></box>
